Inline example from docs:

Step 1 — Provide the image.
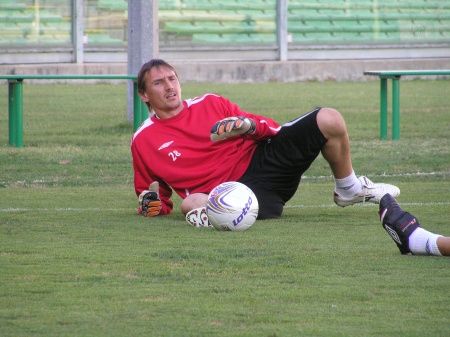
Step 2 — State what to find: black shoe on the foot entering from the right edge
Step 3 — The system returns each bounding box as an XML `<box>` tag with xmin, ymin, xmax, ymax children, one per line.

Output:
<box><xmin>379</xmin><ymin>194</ymin><xmax>420</xmax><ymax>254</ymax></box>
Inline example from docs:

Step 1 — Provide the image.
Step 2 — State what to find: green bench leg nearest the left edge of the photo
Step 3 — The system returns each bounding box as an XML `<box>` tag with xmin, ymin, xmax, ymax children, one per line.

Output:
<box><xmin>8</xmin><ymin>80</ymin><xmax>23</xmax><ymax>147</ymax></box>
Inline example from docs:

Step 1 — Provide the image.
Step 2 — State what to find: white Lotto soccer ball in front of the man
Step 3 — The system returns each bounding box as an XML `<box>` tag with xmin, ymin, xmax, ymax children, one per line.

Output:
<box><xmin>206</xmin><ymin>181</ymin><xmax>259</xmax><ymax>231</ymax></box>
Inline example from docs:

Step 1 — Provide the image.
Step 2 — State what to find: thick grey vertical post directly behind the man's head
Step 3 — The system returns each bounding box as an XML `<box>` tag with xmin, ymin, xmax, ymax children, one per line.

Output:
<box><xmin>128</xmin><ymin>0</ymin><xmax>159</xmax><ymax>125</ymax></box>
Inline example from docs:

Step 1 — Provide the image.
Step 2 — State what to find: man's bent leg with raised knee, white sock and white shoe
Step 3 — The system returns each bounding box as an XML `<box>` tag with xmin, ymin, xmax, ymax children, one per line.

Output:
<box><xmin>317</xmin><ymin>108</ymin><xmax>400</xmax><ymax>207</ymax></box>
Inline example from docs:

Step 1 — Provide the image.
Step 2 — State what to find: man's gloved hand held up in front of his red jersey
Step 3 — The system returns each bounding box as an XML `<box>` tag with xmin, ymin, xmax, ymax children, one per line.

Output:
<box><xmin>211</xmin><ymin>117</ymin><xmax>256</xmax><ymax>142</ymax></box>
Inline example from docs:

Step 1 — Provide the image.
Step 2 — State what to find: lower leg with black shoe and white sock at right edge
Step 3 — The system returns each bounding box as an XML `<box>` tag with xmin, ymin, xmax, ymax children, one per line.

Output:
<box><xmin>379</xmin><ymin>194</ymin><xmax>450</xmax><ymax>256</ymax></box>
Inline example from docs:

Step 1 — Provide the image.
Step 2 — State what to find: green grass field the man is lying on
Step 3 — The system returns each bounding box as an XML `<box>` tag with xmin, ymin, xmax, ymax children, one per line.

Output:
<box><xmin>0</xmin><ymin>80</ymin><xmax>450</xmax><ymax>337</ymax></box>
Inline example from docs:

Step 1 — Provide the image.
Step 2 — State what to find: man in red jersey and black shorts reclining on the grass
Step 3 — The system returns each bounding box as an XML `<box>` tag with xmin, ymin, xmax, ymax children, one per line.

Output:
<box><xmin>131</xmin><ymin>59</ymin><xmax>450</xmax><ymax>258</ymax></box>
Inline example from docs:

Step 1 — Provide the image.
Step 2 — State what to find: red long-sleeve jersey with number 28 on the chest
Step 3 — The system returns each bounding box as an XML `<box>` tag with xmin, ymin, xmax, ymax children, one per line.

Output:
<box><xmin>131</xmin><ymin>94</ymin><xmax>280</xmax><ymax>214</ymax></box>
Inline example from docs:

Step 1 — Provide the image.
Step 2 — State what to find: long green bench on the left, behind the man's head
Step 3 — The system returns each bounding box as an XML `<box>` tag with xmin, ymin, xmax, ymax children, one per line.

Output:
<box><xmin>0</xmin><ymin>75</ymin><xmax>148</xmax><ymax>147</ymax></box>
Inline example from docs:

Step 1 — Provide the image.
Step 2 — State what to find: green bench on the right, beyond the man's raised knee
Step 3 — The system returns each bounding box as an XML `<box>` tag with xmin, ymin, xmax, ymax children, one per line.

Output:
<box><xmin>364</xmin><ymin>69</ymin><xmax>450</xmax><ymax>140</ymax></box>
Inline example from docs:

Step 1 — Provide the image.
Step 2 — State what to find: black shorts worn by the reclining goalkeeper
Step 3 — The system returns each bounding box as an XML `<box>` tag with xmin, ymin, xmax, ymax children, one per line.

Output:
<box><xmin>239</xmin><ymin>108</ymin><xmax>327</xmax><ymax>219</ymax></box>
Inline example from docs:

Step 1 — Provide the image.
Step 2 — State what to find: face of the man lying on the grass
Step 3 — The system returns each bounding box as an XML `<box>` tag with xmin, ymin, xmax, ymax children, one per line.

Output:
<box><xmin>140</xmin><ymin>66</ymin><xmax>183</xmax><ymax>119</ymax></box>
